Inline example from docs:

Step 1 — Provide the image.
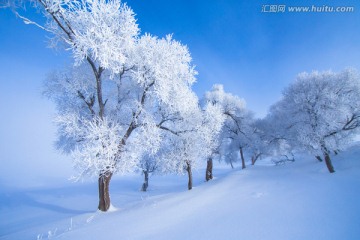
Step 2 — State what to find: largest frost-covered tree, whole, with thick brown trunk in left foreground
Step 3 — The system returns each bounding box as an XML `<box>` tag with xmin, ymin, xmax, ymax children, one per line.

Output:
<box><xmin>20</xmin><ymin>0</ymin><xmax>197</xmax><ymax>211</ymax></box>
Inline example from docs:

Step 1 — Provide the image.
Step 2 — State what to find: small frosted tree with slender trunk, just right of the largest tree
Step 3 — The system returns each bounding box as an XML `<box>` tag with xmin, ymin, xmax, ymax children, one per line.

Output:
<box><xmin>153</xmin><ymin>104</ymin><xmax>223</xmax><ymax>190</ymax></box>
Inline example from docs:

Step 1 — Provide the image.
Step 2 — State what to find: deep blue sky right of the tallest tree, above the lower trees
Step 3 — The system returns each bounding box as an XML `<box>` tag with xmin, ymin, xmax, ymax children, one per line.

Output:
<box><xmin>128</xmin><ymin>0</ymin><xmax>360</xmax><ymax>116</ymax></box>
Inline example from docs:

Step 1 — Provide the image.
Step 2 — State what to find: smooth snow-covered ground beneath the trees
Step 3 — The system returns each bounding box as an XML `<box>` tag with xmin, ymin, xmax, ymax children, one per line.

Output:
<box><xmin>0</xmin><ymin>144</ymin><xmax>360</xmax><ymax>240</ymax></box>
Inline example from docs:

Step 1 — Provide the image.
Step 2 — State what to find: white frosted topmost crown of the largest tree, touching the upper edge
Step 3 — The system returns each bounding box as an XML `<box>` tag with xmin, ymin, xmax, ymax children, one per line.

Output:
<box><xmin>34</xmin><ymin>0</ymin><xmax>139</xmax><ymax>73</ymax></box>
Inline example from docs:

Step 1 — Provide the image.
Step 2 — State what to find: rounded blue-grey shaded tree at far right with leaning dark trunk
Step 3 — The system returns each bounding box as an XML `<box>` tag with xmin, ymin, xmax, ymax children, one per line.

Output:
<box><xmin>270</xmin><ymin>70</ymin><xmax>360</xmax><ymax>173</ymax></box>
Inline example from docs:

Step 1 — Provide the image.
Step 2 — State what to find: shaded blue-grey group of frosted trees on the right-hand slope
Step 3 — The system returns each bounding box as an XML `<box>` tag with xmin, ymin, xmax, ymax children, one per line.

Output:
<box><xmin>205</xmin><ymin>69</ymin><xmax>360</xmax><ymax>173</ymax></box>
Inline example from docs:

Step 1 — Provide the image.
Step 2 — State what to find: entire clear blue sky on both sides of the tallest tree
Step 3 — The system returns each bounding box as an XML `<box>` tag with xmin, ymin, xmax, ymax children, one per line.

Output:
<box><xmin>0</xmin><ymin>0</ymin><xmax>360</xmax><ymax>187</ymax></box>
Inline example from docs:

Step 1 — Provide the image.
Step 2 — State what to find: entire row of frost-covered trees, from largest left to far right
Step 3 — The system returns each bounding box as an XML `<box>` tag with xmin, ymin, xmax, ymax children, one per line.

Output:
<box><xmin>7</xmin><ymin>0</ymin><xmax>360</xmax><ymax>211</ymax></box>
